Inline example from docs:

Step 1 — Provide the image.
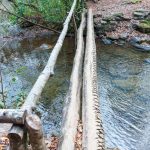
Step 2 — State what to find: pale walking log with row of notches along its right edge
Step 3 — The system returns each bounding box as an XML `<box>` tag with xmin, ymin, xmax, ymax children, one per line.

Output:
<box><xmin>82</xmin><ymin>9</ymin><xmax>105</xmax><ymax>150</ymax></box>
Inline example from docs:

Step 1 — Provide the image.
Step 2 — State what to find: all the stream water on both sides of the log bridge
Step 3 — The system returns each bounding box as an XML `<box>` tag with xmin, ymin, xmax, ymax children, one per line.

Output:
<box><xmin>0</xmin><ymin>35</ymin><xmax>150</xmax><ymax>150</ymax></box>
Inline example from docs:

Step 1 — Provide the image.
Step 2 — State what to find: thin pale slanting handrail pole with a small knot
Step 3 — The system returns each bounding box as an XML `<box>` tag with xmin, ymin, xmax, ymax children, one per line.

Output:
<box><xmin>10</xmin><ymin>0</ymin><xmax>77</xmax><ymax>150</ymax></box>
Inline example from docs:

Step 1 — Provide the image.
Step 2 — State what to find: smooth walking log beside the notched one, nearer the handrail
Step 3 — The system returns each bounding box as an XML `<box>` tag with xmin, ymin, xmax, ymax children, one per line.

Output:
<box><xmin>58</xmin><ymin>12</ymin><xmax>86</xmax><ymax>150</ymax></box>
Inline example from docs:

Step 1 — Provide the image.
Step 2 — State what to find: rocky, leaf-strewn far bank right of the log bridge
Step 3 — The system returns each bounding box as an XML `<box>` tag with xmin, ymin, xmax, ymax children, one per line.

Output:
<box><xmin>87</xmin><ymin>0</ymin><xmax>150</xmax><ymax>51</ymax></box>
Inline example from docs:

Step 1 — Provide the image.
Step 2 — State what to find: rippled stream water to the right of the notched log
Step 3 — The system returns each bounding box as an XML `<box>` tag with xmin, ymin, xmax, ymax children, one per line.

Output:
<box><xmin>97</xmin><ymin>42</ymin><xmax>150</xmax><ymax>150</ymax></box>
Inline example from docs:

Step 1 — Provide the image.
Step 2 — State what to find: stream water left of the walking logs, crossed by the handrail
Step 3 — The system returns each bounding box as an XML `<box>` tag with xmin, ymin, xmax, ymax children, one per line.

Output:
<box><xmin>0</xmin><ymin>35</ymin><xmax>74</xmax><ymax>136</ymax></box>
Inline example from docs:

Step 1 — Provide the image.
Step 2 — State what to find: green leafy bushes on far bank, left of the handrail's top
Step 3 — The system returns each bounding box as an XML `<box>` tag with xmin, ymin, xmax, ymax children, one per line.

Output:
<box><xmin>11</xmin><ymin>0</ymin><xmax>73</xmax><ymax>23</ymax></box>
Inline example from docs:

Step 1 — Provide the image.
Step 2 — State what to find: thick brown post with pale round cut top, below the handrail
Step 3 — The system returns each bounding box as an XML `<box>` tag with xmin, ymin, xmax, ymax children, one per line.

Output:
<box><xmin>26</xmin><ymin>115</ymin><xmax>46</xmax><ymax>150</ymax></box>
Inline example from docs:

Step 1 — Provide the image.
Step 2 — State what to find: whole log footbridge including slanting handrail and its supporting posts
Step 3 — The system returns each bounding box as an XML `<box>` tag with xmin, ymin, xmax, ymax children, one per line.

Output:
<box><xmin>0</xmin><ymin>0</ymin><xmax>105</xmax><ymax>150</ymax></box>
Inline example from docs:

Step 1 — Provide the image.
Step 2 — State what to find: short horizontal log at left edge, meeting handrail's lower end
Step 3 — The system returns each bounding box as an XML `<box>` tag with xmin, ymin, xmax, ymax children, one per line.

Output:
<box><xmin>0</xmin><ymin>109</ymin><xmax>26</xmax><ymax>124</ymax></box>
